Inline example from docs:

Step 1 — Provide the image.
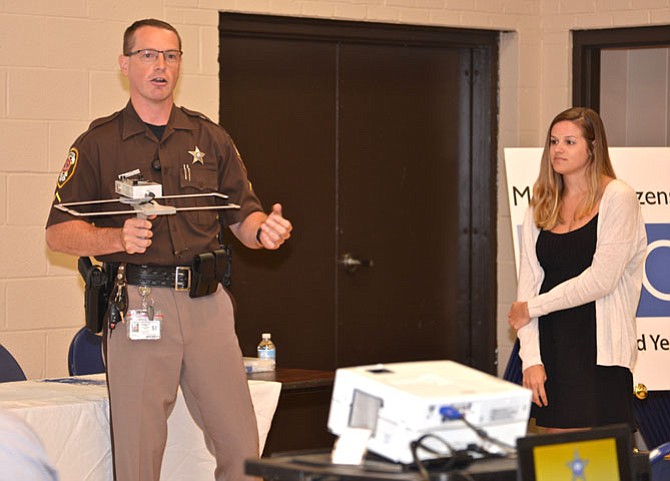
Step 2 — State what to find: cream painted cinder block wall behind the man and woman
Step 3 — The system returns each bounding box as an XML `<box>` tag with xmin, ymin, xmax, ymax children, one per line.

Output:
<box><xmin>0</xmin><ymin>0</ymin><xmax>670</xmax><ymax>379</ymax></box>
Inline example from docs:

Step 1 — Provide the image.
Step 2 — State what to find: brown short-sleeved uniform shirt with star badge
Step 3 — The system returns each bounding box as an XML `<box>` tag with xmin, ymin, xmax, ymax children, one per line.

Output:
<box><xmin>47</xmin><ymin>102</ymin><xmax>262</xmax><ymax>265</ymax></box>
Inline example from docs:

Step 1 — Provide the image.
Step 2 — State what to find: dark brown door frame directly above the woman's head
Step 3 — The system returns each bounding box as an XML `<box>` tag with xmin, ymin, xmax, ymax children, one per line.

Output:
<box><xmin>572</xmin><ymin>25</ymin><xmax>670</xmax><ymax>112</ymax></box>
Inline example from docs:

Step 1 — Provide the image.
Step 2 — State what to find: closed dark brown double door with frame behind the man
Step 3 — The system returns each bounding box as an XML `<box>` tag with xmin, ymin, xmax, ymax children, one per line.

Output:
<box><xmin>220</xmin><ymin>14</ymin><xmax>495</xmax><ymax>371</ymax></box>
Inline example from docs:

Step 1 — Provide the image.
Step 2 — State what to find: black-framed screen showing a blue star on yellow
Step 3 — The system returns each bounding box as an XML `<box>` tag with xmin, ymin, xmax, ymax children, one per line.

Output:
<box><xmin>516</xmin><ymin>424</ymin><xmax>633</xmax><ymax>481</ymax></box>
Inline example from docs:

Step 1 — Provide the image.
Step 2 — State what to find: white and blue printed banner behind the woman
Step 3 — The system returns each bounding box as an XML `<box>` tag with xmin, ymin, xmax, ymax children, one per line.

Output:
<box><xmin>505</xmin><ymin>147</ymin><xmax>670</xmax><ymax>391</ymax></box>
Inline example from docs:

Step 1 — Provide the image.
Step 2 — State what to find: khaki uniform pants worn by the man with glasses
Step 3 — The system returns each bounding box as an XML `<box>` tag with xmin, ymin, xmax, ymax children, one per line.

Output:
<box><xmin>107</xmin><ymin>286</ymin><xmax>259</xmax><ymax>481</ymax></box>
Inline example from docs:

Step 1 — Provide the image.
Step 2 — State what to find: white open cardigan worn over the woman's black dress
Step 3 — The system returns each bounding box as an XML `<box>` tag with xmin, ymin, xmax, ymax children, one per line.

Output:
<box><xmin>517</xmin><ymin>179</ymin><xmax>647</xmax><ymax>370</ymax></box>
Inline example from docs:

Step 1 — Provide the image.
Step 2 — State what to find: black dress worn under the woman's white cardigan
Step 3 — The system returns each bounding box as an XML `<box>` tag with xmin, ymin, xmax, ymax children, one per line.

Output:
<box><xmin>531</xmin><ymin>215</ymin><xmax>633</xmax><ymax>428</ymax></box>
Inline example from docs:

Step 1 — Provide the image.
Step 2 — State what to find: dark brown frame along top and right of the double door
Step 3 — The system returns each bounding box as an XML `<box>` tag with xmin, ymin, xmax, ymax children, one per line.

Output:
<box><xmin>219</xmin><ymin>12</ymin><xmax>500</xmax><ymax>374</ymax></box>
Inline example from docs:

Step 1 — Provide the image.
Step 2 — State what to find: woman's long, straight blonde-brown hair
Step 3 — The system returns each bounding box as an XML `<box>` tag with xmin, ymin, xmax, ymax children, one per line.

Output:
<box><xmin>530</xmin><ymin>107</ymin><xmax>616</xmax><ymax>230</ymax></box>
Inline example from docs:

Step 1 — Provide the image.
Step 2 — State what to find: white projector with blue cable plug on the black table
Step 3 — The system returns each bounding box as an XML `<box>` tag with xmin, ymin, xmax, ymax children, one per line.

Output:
<box><xmin>328</xmin><ymin>361</ymin><xmax>531</xmax><ymax>464</ymax></box>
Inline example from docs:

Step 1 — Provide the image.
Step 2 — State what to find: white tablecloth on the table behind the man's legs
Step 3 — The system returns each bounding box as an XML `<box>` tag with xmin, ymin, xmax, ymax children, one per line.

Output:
<box><xmin>0</xmin><ymin>375</ymin><xmax>281</xmax><ymax>481</ymax></box>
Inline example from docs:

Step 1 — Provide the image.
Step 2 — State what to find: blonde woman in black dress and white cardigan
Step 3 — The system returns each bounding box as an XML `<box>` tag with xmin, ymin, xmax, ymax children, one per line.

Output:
<box><xmin>508</xmin><ymin>107</ymin><xmax>647</xmax><ymax>432</ymax></box>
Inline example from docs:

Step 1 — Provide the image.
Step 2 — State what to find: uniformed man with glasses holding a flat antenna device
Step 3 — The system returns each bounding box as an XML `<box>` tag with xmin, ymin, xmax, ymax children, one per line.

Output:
<box><xmin>46</xmin><ymin>19</ymin><xmax>292</xmax><ymax>481</ymax></box>
